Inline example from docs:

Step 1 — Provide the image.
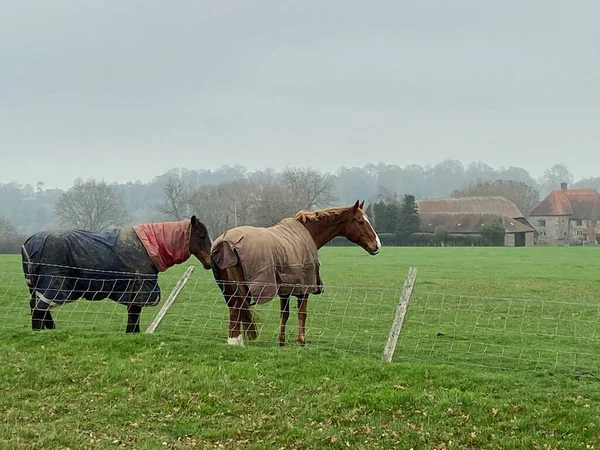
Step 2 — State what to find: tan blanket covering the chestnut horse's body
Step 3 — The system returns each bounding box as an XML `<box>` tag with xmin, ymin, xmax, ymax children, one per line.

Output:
<box><xmin>211</xmin><ymin>218</ymin><xmax>321</xmax><ymax>304</ymax></box>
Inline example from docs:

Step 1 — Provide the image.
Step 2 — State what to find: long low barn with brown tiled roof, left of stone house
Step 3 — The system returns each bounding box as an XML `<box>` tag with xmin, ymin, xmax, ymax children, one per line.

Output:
<box><xmin>417</xmin><ymin>197</ymin><xmax>535</xmax><ymax>247</ymax></box>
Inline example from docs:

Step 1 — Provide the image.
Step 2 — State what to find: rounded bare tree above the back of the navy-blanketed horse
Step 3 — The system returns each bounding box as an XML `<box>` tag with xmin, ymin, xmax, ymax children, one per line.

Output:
<box><xmin>55</xmin><ymin>179</ymin><xmax>127</xmax><ymax>231</ymax></box>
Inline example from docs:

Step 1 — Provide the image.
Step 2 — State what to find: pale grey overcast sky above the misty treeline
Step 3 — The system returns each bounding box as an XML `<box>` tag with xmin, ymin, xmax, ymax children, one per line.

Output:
<box><xmin>0</xmin><ymin>0</ymin><xmax>600</xmax><ymax>189</ymax></box>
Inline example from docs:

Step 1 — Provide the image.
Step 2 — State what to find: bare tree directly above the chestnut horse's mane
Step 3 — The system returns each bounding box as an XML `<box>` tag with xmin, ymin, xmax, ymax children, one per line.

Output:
<box><xmin>281</xmin><ymin>167</ymin><xmax>335</xmax><ymax>209</ymax></box>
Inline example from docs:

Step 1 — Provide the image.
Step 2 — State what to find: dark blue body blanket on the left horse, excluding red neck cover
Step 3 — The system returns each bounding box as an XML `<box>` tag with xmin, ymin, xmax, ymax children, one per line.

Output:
<box><xmin>21</xmin><ymin>228</ymin><xmax>160</xmax><ymax>306</ymax></box>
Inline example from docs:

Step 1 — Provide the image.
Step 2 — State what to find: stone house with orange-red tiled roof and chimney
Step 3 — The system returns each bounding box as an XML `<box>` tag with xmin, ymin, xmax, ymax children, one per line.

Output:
<box><xmin>529</xmin><ymin>183</ymin><xmax>600</xmax><ymax>245</ymax></box>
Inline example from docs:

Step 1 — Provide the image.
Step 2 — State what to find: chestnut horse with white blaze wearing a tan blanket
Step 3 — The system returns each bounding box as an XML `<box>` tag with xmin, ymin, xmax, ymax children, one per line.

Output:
<box><xmin>211</xmin><ymin>200</ymin><xmax>381</xmax><ymax>346</ymax></box>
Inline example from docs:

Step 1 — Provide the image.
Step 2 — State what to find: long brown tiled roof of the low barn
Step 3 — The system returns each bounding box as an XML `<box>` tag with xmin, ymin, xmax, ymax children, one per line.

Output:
<box><xmin>417</xmin><ymin>196</ymin><xmax>524</xmax><ymax>218</ymax></box>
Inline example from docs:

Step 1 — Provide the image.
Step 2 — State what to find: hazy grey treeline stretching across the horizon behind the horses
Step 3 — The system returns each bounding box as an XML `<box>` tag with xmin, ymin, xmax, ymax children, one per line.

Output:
<box><xmin>0</xmin><ymin>160</ymin><xmax>600</xmax><ymax>251</ymax></box>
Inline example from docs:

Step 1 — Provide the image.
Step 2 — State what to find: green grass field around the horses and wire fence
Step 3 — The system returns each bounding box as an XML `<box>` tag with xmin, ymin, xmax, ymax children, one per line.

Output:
<box><xmin>0</xmin><ymin>248</ymin><xmax>600</xmax><ymax>449</ymax></box>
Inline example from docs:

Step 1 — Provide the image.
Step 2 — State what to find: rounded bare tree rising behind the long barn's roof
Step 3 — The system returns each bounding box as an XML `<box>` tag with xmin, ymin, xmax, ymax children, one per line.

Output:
<box><xmin>452</xmin><ymin>179</ymin><xmax>540</xmax><ymax>216</ymax></box>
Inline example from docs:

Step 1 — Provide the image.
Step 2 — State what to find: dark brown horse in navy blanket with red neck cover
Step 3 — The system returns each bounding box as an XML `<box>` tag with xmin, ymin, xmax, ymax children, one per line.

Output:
<box><xmin>21</xmin><ymin>215</ymin><xmax>212</xmax><ymax>333</ymax></box>
